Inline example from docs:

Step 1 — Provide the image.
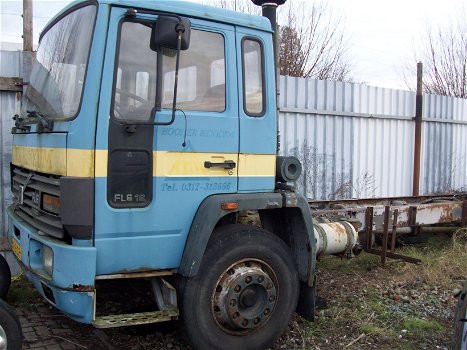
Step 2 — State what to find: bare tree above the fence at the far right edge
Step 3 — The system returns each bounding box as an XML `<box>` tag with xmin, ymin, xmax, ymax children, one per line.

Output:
<box><xmin>403</xmin><ymin>11</ymin><xmax>467</xmax><ymax>98</ymax></box>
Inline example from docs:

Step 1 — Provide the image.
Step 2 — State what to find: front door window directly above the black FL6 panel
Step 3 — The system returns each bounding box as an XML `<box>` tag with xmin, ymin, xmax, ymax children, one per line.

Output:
<box><xmin>112</xmin><ymin>22</ymin><xmax>157</xmax><ymax>121</ymax></box>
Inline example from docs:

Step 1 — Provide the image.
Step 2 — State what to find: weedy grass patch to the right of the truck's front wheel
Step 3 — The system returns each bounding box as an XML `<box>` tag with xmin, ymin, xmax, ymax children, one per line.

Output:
<box><xmin>298</xmin><ymin>229</ymin><xmax>467</xmax><ymax>350</ymax></box>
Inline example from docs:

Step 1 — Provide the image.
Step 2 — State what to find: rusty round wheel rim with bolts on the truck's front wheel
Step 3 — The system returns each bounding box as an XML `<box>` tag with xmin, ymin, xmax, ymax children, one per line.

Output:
<box><xmin>211</xmin><ymin>259</ymin><xmax>279</xmax><ymax>335</ymax></box>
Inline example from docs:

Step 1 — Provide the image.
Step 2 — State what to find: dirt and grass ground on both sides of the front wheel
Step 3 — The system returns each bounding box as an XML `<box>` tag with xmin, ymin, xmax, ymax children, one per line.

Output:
<box><xmin>7</xmin><ymin>234</ymin><xmax>467</xmax><ymax>350</ymax></box>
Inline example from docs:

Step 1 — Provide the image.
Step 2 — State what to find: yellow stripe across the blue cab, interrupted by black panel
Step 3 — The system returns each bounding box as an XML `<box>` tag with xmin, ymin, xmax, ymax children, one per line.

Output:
<box><xmin>12</xmin><ymin>146</ymin><xmax>276</xmax><ymax>177</ymax></box>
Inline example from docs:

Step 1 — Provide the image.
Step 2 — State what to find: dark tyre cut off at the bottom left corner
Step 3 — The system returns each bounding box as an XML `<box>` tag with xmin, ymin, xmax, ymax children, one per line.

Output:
<box><xmin>0</xmin><ymin>300</ymin><xmax>23</xmax><ymax>350</ymax></box>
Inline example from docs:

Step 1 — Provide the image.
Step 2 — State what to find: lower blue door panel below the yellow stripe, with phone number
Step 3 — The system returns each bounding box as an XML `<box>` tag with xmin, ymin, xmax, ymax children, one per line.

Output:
<box><xmin>95</xmin><ymin>177</ymin><xmax>237</xmax><ymax>274</ymax></box>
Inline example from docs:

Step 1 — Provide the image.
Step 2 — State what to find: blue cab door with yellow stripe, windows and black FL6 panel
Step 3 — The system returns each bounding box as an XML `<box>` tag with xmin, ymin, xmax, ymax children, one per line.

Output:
<box><xmin>95</xmin><ymin>7</ymin><xmax>239</xmax><ymax>274</ymax></box>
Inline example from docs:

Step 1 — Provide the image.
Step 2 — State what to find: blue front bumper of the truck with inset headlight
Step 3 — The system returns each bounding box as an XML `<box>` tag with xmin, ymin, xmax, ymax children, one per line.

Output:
<box><xmin>7</xmin><ymin>207</ymin><xmax>96</xmax><ymax>324</ymax></box>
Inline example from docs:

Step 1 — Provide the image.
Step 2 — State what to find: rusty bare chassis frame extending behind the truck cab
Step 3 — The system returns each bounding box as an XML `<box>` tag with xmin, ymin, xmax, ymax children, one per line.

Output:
<box><xmin>309</xmin><ymin>193</ymin><xmax>467</xmax><ymax>265</ymax></box>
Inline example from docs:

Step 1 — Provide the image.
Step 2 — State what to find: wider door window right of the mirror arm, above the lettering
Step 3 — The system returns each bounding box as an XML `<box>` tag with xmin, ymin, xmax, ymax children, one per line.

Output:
<box><xmin>162</xmin><ymin>29</ymin><xmax>225</xmax><ymax>112</ymax></box>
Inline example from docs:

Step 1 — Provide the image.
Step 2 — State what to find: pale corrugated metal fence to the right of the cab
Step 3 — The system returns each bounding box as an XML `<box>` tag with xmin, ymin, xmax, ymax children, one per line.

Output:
<box><xmin>279</xmin><ymin>77</ymin><xmax>467</xmax><ymax>199</ymax></box>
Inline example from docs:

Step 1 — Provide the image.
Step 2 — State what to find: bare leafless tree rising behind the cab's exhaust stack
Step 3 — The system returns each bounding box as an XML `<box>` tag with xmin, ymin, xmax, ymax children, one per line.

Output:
<box><xmin>207</xmin><ymin>0</ymin><xmax>352</xmax><ymax>81</ymax></box>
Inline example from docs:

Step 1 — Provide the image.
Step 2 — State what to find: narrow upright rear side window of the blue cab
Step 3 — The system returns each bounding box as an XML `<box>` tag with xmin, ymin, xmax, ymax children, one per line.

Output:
<box><xmin>242</xmin><ymin>38</ymin><xmax>264</xmax><ymax>117</ymax></box>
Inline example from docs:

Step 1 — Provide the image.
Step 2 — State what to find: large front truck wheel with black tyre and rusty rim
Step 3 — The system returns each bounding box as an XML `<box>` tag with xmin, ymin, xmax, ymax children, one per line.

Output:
<box><xmin>180</xmin><ymin>225</ymin><xmax>299</xmax><ymax>350</ymax></box>
